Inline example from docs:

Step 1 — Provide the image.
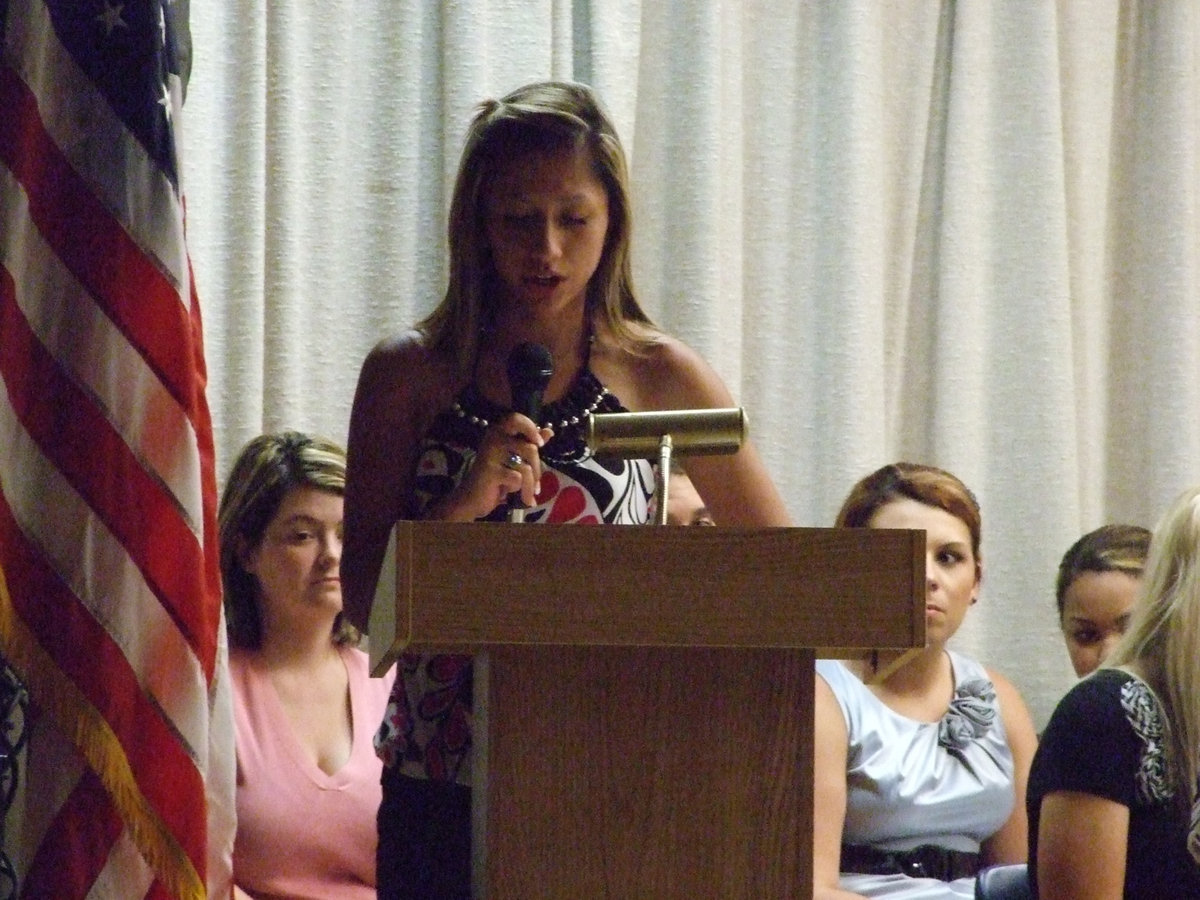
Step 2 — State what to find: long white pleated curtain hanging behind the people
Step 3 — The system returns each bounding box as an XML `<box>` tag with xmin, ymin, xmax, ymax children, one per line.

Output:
<box><xmin>184</xmin><ymin>0</ymin><xmax>1200</xmax><ymax>726</ymax></box>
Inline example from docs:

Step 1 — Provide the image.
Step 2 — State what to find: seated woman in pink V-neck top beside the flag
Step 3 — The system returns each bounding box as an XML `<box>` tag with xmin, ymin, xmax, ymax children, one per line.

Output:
<box><xmin>220</xmin><ymin>432</ymin><xmax>395</xmax><ymax>900</ymax></box>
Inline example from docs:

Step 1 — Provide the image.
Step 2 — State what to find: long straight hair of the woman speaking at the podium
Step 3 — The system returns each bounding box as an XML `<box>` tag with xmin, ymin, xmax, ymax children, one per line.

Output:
<box><xmin>416</xmin><ymin>82</ymin><xmax>653</xmax><ymax>377</ymax></box>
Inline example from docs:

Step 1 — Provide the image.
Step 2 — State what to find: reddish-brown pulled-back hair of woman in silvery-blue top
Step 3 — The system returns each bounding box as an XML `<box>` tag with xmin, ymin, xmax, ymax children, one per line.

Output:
<box><xmin>835</xmin><ymin>462</ymin><xmax>983</xmax><ymax>576</ymax></box>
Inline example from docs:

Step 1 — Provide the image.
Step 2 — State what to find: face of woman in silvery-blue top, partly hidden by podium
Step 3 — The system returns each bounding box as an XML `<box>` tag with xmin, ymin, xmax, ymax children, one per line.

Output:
<box><xmin>870</xmin><ymin>497</ymin><xmax>979</xmax><ymax>646</ymax></box>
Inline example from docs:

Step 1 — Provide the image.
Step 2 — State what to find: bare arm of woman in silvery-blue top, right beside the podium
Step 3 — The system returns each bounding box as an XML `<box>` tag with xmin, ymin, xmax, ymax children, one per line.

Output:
<box><xmin>812</xmin><ymin>676</ymin><xmax>860</xmax><ymax>900</ymax></box>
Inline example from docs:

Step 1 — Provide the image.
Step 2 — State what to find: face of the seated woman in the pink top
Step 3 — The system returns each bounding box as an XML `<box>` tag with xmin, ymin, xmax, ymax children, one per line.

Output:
<box><xmin>242</xmin><ymin>487</ymin><xmax>342</xmax><ymax>629</ymax></box>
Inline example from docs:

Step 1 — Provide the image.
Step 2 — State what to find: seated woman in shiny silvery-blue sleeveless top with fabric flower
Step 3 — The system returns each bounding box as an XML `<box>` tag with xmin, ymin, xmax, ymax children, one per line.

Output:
<box><xmin>812</xmin><ymin>462</ymin><xmax>1037</xmax><ymax>900</ymax></box>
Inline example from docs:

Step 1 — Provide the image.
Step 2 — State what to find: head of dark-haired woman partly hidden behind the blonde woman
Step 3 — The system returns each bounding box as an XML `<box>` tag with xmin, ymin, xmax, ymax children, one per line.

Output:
<box><xmin>1055</xmin><ymin>524</ymin><xmax>1150</xmax><ymax>678</ymax></box>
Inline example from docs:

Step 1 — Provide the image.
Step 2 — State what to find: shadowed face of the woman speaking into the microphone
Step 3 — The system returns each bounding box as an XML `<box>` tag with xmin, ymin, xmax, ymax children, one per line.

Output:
<box><xmin>484</xmin><ymin>150</ymin><xmax>608</xmax><ymax>311</ymax></box>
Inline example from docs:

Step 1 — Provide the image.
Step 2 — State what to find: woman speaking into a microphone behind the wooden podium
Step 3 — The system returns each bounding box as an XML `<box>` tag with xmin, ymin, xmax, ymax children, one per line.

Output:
<box><xmin>342</xmin><ymin>82</ymin><xmax>788</xmax><ymax>900</ymax></box>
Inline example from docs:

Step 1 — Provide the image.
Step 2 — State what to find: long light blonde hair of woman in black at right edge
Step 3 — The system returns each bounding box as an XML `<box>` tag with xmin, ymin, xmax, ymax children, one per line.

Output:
<box><xmin>1104</xmin><ymin>486</ymin><xmax>1200</xmax><ymax>805</ymax></box>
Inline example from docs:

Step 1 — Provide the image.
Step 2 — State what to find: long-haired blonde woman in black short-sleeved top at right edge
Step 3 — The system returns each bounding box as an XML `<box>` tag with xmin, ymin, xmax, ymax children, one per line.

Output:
<box><xmin>1027</xmin><ymin>487</ymin><xmax>1200</xmax><ymax>900</ymax></box>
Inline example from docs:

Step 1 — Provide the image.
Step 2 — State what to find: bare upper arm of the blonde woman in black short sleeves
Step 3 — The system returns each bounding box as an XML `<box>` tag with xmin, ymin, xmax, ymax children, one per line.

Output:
<box><xmin>1031</xmin><ymin>791</ymin><xmax>1129</xmax><ymax>900</ymax></box>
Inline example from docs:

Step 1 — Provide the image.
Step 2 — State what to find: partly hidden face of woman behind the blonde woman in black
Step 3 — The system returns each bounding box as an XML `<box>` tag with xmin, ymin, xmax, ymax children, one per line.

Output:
<box><xmin>1060</xmin><ymin>571</ymin><xmax>1139</xmax><ymax>678</ymax></box>
